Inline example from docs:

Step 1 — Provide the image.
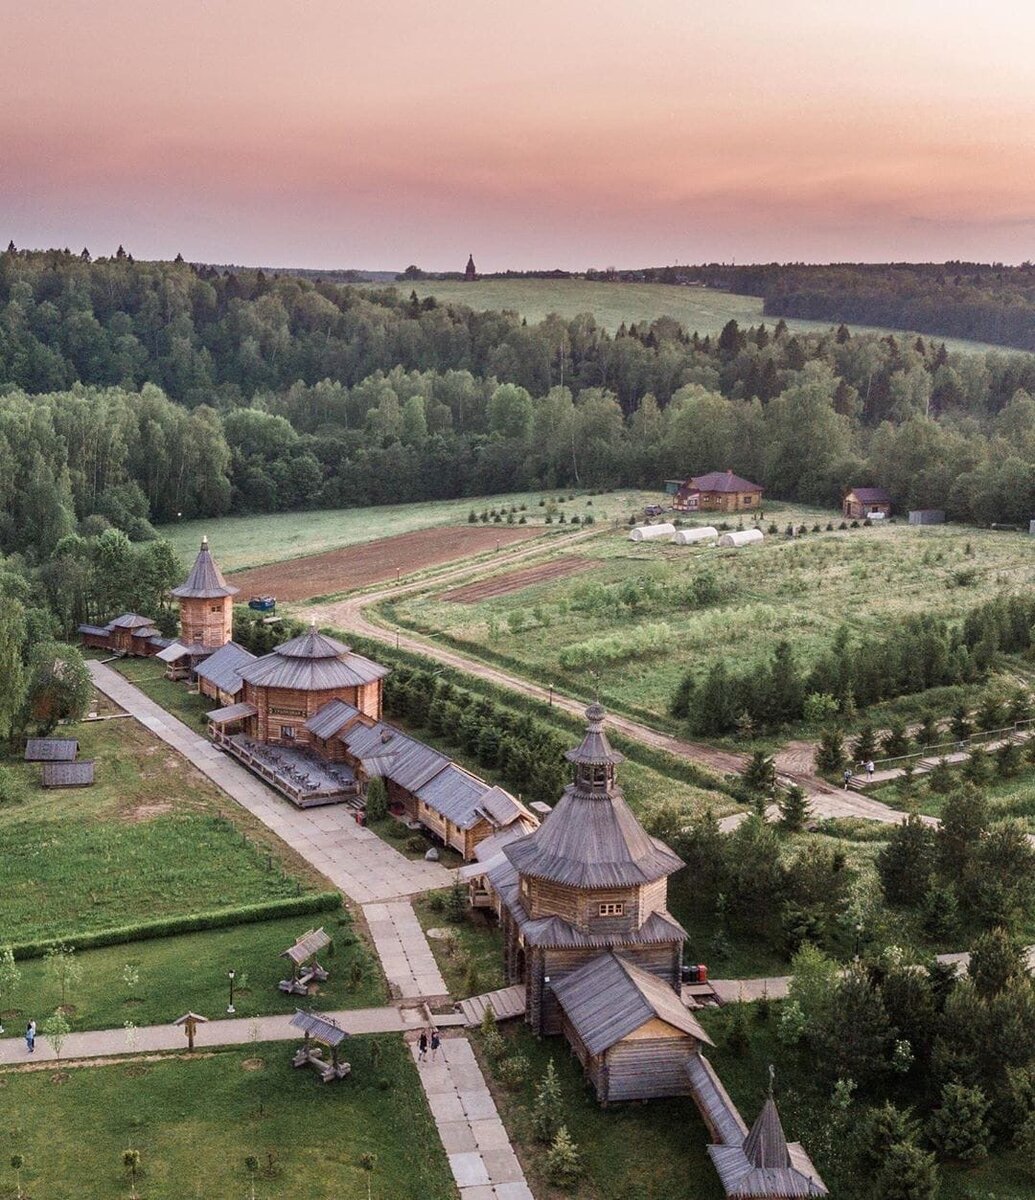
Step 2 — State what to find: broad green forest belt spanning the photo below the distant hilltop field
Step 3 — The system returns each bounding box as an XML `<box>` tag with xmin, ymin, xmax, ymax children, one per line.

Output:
<box><xmin>0</xmin><ymin>251</ymin><xmax>1035</xmax><ymax>562</ymax></box>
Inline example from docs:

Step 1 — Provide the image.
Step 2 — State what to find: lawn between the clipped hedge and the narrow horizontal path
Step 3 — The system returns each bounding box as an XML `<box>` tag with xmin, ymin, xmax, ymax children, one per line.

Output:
<box><xmin>4</xmin><ymin>911</ymin><xmax>387</xmax><ymax>1037</ymax></box>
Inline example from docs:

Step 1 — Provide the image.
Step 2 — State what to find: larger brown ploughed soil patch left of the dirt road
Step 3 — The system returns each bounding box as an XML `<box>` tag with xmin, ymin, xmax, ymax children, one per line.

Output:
<box><xmin>231</xmin><ymin>526</ymin><xmax>543</xmax><ymax>600</ymax></box>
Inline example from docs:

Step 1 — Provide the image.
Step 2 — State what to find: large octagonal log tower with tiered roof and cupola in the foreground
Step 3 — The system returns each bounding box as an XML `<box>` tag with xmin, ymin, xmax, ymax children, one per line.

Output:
<box><xmin>487</xmin><ymin>704</ymin><xmax>687</xmax><ymax>1034</ymax></box>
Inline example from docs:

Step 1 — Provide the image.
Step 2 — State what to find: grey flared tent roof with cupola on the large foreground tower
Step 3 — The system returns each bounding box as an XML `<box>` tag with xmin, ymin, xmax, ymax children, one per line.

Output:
<box><xmin>503</xmin><ymin>704</ymin><xmax>683</xmax><ymax>888</ymax></box>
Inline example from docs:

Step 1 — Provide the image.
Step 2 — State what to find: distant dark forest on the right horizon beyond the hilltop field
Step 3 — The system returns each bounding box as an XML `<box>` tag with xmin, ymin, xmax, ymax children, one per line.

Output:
<box><xmin>677</xmin><ymin>263</ymin><xmax>1035</xmax><ymax>350</ymax></box>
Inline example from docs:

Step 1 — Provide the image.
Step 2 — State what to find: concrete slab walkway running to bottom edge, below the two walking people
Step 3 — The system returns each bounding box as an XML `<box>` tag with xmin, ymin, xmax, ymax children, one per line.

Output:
<box><xmin>412</xmin><ymin>1037</ymin><xmax>534</xmax><ymax>1200</ymax></box>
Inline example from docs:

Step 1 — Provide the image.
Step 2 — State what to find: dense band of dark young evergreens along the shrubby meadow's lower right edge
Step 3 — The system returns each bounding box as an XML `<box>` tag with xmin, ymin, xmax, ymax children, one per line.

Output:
<box><xmin>671</xmin><ymin>595</ymin><xmax>1035</xmax><ymax>737</ymax></box>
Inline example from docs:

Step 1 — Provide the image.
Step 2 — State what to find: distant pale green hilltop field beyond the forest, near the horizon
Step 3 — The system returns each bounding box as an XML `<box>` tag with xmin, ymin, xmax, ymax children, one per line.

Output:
<box><xmin>377</xmin><ymin>280</ymin><xmax>1018</xmax><ymax>354</ymax></box>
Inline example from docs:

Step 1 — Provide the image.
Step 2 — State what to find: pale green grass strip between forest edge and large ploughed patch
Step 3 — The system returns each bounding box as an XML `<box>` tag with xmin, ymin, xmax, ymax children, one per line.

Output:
<box><xmin>158</xmin><ymin>490</ymin><xmax>657</xmax><ymax>571</ymax></box>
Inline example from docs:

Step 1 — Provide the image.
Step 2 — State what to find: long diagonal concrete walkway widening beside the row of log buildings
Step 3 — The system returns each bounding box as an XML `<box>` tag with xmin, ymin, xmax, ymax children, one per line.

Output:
<box><xmin>88</xmin><ymin>661</ymin><xmax>453</xmax><ymax>902</ymax></box>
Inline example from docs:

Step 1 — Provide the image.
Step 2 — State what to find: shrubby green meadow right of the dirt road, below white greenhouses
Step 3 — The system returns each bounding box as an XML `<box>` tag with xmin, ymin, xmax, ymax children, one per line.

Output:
<box><xmin>381</xmin><ymin>505</ymin><xmax>1035</xmax><ymax>721</ymax></box>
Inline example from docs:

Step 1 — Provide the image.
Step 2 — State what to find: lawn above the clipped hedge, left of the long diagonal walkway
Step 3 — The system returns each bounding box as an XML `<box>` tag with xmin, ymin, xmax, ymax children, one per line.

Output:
<box><xmin>0</xmin><ymin>700</ymin><xmax>327</xmax><ymax>942</ymax></box>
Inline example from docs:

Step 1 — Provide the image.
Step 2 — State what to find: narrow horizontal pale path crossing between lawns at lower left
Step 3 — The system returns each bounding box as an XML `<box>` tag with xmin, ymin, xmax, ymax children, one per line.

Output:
<box><xmin>0</xmin><ymin>1007</ymin><xmax>424</xmax><ymax>1067</ymax></box>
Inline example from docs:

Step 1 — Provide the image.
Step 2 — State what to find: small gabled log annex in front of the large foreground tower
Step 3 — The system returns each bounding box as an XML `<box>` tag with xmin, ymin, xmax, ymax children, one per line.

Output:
<box><xmin>554</xmin><ymin>953</ymin><xmax>713</xmax><ymax>1104</ymax></box>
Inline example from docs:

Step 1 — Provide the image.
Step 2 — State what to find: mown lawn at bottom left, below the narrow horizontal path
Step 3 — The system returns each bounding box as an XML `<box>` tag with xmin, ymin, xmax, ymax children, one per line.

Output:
<box><xmin>0</xmin><ymin>1036</ymin><xmax>456</xmax><ymax>1200</ymax></box>
